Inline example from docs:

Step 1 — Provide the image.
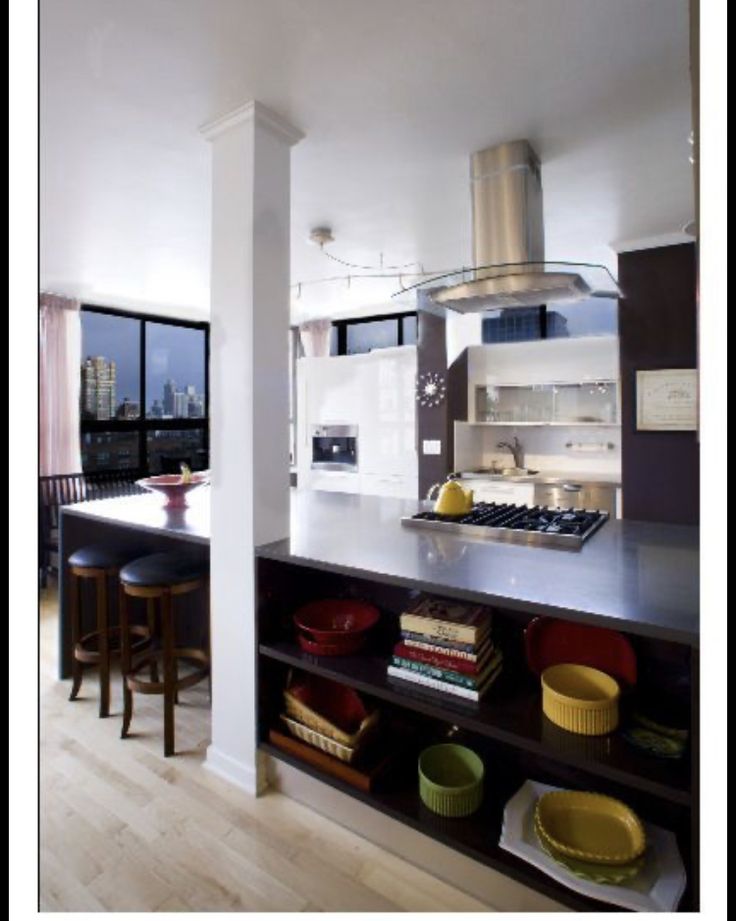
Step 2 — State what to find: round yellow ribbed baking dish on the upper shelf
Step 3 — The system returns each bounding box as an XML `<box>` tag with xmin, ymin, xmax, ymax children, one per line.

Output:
<box><xmin>542</xmin><ymin>664</ymin><xmax>620</xmax><ymax>736</ymax></box>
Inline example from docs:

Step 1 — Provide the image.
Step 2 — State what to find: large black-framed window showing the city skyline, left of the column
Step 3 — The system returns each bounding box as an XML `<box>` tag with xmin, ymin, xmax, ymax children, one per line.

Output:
<box><xmin>80</xmin><ymin>305</ymin><xmax>209</xmax><ymax>474</ymax></box>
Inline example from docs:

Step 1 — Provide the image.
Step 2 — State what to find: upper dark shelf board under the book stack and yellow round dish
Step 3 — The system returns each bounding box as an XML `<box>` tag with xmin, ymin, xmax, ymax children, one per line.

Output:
<box><xmin>259</xmin><ymin>641</ymin><xmax>692</xmax><ymax>807</ymax></box>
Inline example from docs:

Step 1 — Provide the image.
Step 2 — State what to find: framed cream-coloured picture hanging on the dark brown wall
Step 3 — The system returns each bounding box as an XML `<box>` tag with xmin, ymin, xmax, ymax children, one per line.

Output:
<box><xmin>636</xmin><ymin>368</ymin><xmax>698</xmax><ymax>432</ymax></box>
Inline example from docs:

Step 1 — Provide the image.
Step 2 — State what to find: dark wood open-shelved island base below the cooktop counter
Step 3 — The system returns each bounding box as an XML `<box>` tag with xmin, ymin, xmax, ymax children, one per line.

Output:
<box><xmin>256</xmin><ymin>499</ymin><xmax>699</xmax><ymax>911</ymax></box>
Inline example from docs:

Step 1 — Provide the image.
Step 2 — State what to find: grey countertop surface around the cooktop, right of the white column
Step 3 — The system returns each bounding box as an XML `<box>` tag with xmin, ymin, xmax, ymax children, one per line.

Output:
<box><xmin>256</xmin><ymin>489</ymin><xmax>699</xmax><ymax>646</ymax></box>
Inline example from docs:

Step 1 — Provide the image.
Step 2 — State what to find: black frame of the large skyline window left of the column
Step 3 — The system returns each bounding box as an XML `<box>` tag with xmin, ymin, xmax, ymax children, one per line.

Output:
<box><xmin>79</xmin><ymin>303</ymin><xmax>210</xmax><ymax>476</ymax></box>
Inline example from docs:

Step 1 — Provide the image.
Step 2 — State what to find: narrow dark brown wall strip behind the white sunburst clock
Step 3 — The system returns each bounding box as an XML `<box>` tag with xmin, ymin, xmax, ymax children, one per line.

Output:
<box><xmin>417</xmin><ymin>310</ymin><xmax>449</xmax><ymax>499</ymax></box>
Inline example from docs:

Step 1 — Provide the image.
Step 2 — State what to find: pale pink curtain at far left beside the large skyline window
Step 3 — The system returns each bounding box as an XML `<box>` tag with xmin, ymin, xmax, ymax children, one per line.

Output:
<box><xmin>38</xmin><ymin>294</ymin><xmax>82</xmax><ymax>476</ymax></box>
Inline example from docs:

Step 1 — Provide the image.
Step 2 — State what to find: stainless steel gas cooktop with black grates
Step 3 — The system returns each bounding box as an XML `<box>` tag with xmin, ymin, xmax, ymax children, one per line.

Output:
<box><xmin>401</xmin><ymin>502</ymin><xmax>608</xmax><ymax>550</ymax></box>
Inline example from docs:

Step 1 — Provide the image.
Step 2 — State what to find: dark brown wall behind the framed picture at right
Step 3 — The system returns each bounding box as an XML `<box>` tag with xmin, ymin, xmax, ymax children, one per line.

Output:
<box><xmin>619</xmin><ymin>243</ymin><xmax>700</xmax><ymax>524</ymax></box>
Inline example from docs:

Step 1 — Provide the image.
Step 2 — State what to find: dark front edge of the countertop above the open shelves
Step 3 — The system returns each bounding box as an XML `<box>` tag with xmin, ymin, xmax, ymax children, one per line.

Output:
<box><xmin>255</xmin><ymin>541</ymin><xmax>700</xmax><ymax>649</ymax></box>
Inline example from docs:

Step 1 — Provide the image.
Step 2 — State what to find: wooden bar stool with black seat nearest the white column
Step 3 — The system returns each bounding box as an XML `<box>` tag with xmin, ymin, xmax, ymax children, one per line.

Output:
<box><xmin>120</xmin><ymin>553</ymin><xmax>210</xmax><ymax>757</ymax></box>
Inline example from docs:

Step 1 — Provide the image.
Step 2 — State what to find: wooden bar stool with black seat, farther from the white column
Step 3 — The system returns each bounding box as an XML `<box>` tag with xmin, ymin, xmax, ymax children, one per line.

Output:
<box><xmin>67</xmin><ymin>544</ymin><xmax>153</xmax><ymax>717</ymax></box>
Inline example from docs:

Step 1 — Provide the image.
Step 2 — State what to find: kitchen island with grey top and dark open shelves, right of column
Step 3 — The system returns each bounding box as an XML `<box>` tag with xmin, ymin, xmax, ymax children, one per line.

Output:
<box><xmin>256</xmin><ymin>490</ymin><xmax>699</xmax><ymax>910</ymax></box>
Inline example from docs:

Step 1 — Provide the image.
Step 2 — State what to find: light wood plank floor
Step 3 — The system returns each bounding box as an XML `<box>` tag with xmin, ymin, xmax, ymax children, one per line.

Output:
<box><xmin>40</xmin><ymin>588</ymin><xmax>500</xmax><ymax>912</ymax></box>
